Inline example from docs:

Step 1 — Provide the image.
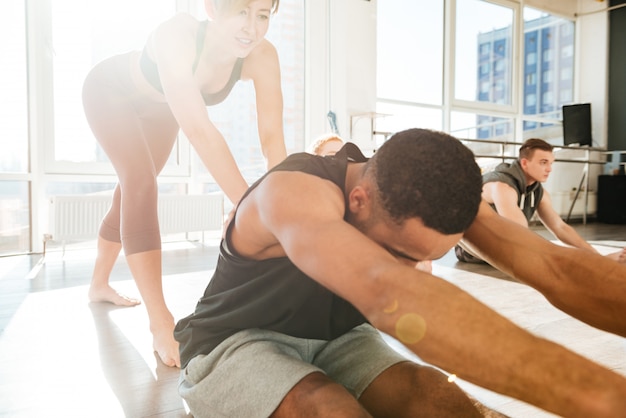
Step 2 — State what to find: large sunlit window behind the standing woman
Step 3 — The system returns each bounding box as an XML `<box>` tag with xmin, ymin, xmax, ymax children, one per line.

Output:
<box><xmin>0</xmin><ymin>0</ymin><xmax>305</xmax><ymax>255</ymax></box>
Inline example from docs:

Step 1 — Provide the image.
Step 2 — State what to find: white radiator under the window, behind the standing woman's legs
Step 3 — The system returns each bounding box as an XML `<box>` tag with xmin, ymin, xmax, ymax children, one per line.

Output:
<box><xmin>49</xmin><ymin>193</ymin><xmax>224</xmax><ymax>241</ymax></box>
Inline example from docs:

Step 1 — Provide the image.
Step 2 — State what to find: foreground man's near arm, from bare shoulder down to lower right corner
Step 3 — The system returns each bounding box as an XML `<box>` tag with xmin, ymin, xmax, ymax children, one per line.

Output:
<box><xmin>250</xmin><ymin>174</ymin><xmax>626</xmax><ymax>417</ymax></box>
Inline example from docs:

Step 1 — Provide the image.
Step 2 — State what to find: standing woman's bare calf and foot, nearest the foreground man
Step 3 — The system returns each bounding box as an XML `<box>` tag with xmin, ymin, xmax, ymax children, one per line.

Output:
<box><xmin>126</xmin><ymin>250</ymin><xmax>180</xmax><ymax>367</ymax></box>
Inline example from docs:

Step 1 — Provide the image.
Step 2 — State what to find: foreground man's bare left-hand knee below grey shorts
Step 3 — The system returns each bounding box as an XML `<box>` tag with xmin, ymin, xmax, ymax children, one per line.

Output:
<box><xmin>272</xmin><ymin>373</ymin><xmax>371</xmax><ymax>418</ymax></box>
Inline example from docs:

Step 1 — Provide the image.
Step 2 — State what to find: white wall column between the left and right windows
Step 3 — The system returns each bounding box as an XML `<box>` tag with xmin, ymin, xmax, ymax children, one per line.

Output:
<box><xmin>306</xmin><ymin>0</ymin><xmax>376</xmax><ymax>149</ymax></box>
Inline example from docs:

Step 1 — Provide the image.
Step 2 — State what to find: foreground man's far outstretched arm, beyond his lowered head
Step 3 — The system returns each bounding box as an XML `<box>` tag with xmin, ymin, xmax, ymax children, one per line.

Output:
<box><xmin>463</xmin><ymin>202</ymin><xmax>626</xmax><ymax>337</ymax></box>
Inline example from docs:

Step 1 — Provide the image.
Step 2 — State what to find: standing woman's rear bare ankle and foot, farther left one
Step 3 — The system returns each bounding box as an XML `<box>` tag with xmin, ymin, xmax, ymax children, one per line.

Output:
<box><xmin>87</xmin><ymin>236</ymin><xmax>141</xmax><ymax>306</ymax></box>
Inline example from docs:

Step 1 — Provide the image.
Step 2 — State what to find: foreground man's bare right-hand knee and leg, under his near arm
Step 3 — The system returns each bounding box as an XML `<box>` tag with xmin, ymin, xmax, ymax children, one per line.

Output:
<box><xmin>359</xmin><ymin>361</ymin><xmax>482</xmax><ymax>418</ymax></box>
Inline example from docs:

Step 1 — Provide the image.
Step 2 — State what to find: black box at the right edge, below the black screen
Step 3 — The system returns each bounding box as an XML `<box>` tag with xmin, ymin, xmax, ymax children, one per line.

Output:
<box><xmin>598</xmin><ymin>175</ymin><xmax>626</xmax><ymax>224</ymax></box>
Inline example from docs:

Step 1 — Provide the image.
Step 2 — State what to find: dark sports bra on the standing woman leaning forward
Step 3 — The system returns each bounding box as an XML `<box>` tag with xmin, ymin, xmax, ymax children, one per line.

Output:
<box><xmin>139</xmin><ymin>20</ymin><xmax>243</xmax><ymax>106</ymax></box>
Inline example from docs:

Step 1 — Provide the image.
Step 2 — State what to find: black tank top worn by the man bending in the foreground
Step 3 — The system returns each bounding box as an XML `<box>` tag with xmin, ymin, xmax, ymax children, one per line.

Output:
<box><xmin>174</xmin><ymin>143</ymin><xmax>367</xmax><ymax>367</ymax></box>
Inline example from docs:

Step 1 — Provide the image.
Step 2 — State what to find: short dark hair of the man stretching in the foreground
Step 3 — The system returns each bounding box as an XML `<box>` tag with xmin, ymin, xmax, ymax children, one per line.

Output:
<box><xmin>367</xmin><ymin>129</ymin><xmax>482</xmax><ymax>234</ymax></box>
